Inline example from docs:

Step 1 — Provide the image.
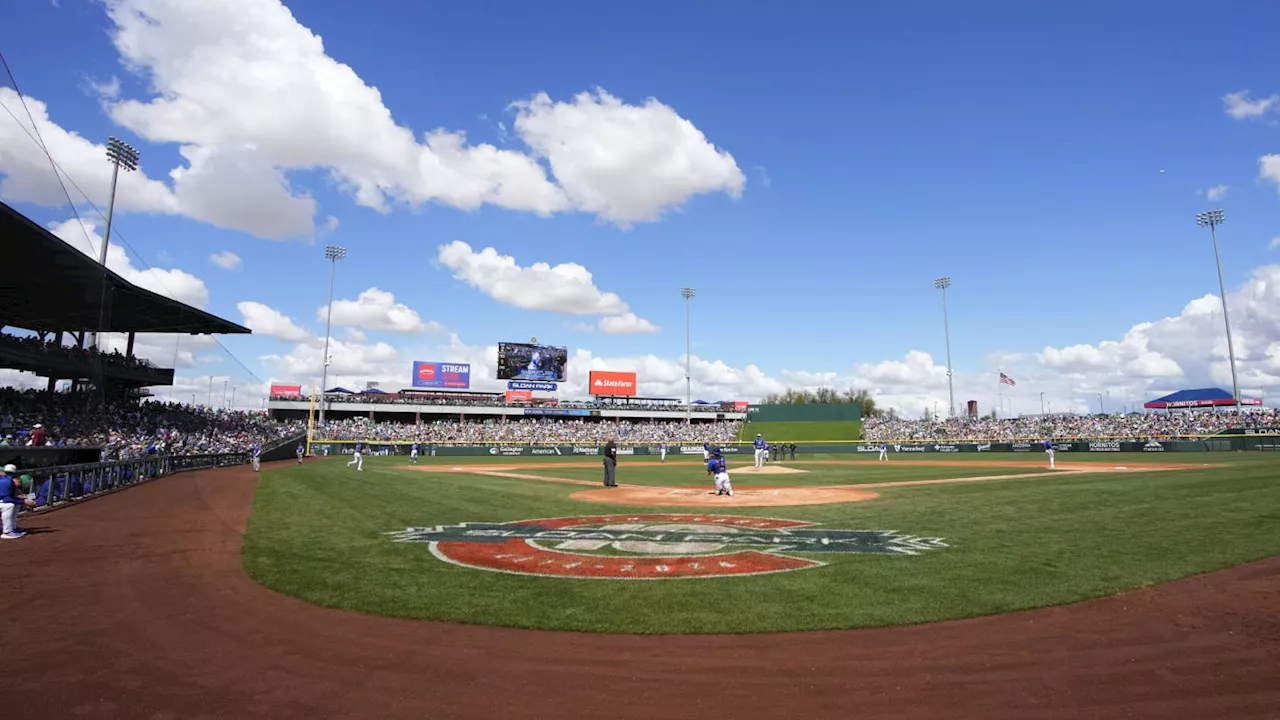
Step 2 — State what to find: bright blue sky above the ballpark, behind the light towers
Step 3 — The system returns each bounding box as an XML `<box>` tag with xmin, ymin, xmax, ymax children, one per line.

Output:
<box><xmin>0</xmin><ymin>0</ymin><xmax>1280</xmax><ymax>410</ymax></box>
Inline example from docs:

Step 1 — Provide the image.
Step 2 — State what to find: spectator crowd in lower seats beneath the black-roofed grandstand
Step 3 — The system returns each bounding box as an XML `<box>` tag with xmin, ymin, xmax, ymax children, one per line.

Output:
<box><xmin>0</xmin><ymin>388</ymin><xmax>306</xmax><ymax>460</ymax></box>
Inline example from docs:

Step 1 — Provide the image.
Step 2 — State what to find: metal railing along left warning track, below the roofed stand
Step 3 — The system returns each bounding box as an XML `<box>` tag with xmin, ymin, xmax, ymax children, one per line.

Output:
<box><xmin>19</xmin><ymin>452</ymin><xmax>248</xmax><ymax>514</ymax></box>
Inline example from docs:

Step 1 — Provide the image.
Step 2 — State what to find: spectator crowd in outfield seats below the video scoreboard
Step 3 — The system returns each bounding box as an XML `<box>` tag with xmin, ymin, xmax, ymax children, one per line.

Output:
<box><xmin>312</xmin><ymin>418</ymin><xmax>741</xmax><ymax>445</ymax></box>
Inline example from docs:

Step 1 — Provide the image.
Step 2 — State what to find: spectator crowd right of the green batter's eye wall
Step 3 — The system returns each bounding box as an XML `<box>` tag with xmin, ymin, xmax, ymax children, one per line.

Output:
<box><xmin>863</xmin><ymin>407</ymin><xmax>1280</xmax><ymax>442</ymax></box>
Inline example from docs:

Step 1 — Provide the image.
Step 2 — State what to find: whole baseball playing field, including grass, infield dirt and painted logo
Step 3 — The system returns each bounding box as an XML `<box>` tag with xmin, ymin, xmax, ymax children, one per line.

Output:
<box><xmin>242</xmin><ymin>454</ymin><xmax>1280</xmax><ymax>634</ymax></box>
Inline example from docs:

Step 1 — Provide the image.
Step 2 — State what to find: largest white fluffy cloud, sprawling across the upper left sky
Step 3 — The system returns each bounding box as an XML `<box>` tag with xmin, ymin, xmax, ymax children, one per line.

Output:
<box><xmin>0</xmin><ymin>0</ymin><xmax>746</xmax><ymax>240</ymax></box>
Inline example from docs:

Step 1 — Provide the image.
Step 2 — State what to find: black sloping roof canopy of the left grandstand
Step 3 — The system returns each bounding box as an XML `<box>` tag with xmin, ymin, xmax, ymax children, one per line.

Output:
<box><xmin>0</xmin><ymin>202</ymin><xmax>251</xmax><ymax>334</ymax></box>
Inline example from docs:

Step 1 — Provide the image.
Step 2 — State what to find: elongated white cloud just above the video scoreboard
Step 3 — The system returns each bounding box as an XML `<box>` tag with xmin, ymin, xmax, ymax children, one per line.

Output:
<box><xmin>436</xmin><ymin>241</ymin><xmax>659</xmax><ymax>334</ymax></box>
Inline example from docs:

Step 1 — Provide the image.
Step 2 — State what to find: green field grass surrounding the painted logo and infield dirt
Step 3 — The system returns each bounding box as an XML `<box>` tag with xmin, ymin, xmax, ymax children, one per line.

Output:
<box><xmin>243</xmin><ymin>454</ymin><xmax>1280</xmax><ymax>633</ymax></box>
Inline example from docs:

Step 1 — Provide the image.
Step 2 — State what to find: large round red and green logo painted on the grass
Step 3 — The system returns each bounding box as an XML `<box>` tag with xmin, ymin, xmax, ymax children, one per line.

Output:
<box><xmin>388</xmin><ymin>514</ymin><xmax>947</xmax><ymax>580</ymax></box>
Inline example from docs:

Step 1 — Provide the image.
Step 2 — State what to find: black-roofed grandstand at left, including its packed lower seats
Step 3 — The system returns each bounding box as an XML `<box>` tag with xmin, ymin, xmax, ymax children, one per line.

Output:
<box><xmin>0</xmin><ymin>202</ymin><xmax>303</xmax><ymax>469</ymax></box>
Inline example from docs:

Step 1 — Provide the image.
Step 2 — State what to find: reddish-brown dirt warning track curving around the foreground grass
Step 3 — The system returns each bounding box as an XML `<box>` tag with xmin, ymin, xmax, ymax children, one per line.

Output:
<box><xmin>0</xmin><ymin>468</ymin><xmax>1280</xmax><ymax>720</ymax></box>
